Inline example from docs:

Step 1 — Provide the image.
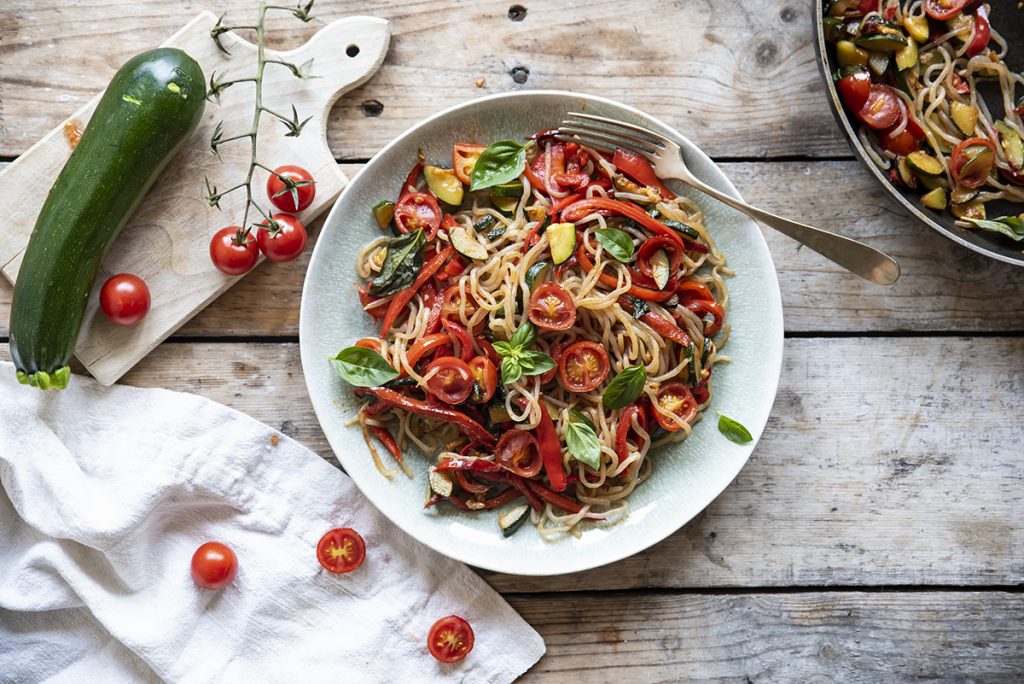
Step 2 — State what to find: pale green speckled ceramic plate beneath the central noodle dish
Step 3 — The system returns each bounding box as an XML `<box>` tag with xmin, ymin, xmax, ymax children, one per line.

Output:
<box><xmin>300</xmin><ymin>91</ymin><xmax>782</xmax><ymax>575</ymax></box>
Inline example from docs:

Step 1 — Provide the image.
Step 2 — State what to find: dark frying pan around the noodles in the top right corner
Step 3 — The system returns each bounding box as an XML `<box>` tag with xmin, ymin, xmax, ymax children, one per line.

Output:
<box><xmin>814</xmin><ymin>5</ymin><xmax>1024</xmax><ymax>266</ymax></box>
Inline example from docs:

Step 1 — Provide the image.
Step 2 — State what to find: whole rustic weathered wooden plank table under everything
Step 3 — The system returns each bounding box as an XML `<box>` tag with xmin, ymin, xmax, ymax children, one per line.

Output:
<box><xmin>0</xmin><ymin>0</ymin><xmax>1024</xmax><ymax>681</ymax></box>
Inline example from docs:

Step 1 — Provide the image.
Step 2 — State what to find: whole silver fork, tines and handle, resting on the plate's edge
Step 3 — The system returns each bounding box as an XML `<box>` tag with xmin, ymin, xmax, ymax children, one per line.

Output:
<box><xmin>555</xmin><ymin>112</ymin><xmax>899</xmax><ymax>285</ymax></box>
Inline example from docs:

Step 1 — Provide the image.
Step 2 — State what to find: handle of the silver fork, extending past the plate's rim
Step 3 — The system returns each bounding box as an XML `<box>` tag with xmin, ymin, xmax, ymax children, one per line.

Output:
<box><xmin>680</xmin><ymin>178</ymin><xmax>899</xmax><ymax>285</ymax></box>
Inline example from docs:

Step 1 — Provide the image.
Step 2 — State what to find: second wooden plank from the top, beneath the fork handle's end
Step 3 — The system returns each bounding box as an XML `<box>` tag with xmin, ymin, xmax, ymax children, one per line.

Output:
<box><xmin>0</xmin><ymin>162</ymin><xmax>1024</xmax><ymax>337</ymax></box>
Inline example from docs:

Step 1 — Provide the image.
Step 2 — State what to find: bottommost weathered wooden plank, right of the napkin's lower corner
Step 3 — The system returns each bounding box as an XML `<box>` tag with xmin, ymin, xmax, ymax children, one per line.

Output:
<box><xmin>509</xmin><ymin>592</ymin><xmax>1024</xmax><ymax>683</ymax></box>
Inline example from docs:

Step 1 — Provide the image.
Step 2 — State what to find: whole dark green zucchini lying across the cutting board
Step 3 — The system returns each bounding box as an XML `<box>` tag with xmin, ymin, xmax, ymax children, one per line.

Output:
<box><xmin>10</xmin><ymin>48</ymin><xmax>206</xmax><ymax>389</ymax></box>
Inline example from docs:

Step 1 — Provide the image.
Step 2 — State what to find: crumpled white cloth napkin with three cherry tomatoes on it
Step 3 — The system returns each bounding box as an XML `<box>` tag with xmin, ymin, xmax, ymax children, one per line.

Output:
<box><xmin>0</xmin><ymin>364</ymin><xmax>544</xmax><ymax>683</ymax></box>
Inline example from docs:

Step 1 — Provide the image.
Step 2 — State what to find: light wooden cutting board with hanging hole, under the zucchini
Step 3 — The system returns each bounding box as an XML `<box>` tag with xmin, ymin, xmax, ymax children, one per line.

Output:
<box><xmin>0</xmin><ymin>10</ymin><xmax>390</xmax><ymax>385</ymax></box>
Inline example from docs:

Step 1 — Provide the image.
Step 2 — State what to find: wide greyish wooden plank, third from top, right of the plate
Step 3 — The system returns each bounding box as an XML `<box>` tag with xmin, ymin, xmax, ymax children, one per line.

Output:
<box><xmin>0</xmin><ymin>338</ymin><xmax>1024</xmax><ymax>592</ymax></box>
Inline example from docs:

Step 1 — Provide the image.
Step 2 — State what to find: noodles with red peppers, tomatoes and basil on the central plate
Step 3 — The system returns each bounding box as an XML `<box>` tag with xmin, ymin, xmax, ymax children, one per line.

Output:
<box><xmin>335</xmin><ymin>131</ymin><xmax>730</xmax><ymax>537</ymax></box>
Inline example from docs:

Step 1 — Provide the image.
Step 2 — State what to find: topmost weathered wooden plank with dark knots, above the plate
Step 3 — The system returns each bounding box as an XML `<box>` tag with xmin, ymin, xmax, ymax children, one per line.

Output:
<box><xmin>0</xmin><ymin>0</ymin><xmax>849</xmax><ymax>159</ymax></box>
